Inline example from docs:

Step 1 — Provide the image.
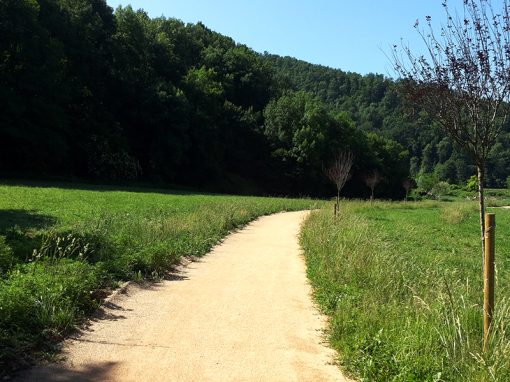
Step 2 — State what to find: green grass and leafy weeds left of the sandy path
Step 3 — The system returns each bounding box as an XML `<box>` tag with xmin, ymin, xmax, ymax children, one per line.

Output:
<box><xmin>0</xmin><ymin>183</ymin><xmax>317</xmax><ymax>375</ymax></box>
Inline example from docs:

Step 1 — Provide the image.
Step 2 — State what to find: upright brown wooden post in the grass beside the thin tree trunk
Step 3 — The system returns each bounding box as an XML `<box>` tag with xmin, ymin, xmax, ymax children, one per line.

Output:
<box><xmin>483</xmin><ymin>214</ymin><xmax>496</xmax><ymax>351</ymax></box>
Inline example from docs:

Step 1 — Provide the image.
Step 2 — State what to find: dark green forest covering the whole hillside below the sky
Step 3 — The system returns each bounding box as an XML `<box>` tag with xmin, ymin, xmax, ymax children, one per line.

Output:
<box><xmin>0</xmin><ymin>0</ymin><xmax>510</xmax><ymax>198</ymax></box>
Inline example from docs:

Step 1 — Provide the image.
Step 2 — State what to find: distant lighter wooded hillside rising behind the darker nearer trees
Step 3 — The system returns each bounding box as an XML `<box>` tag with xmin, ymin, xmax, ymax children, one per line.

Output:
<box><xmin>264</xmin><ymin>54</ymin><xmax>510</xmax><ymax>187</ymax></box>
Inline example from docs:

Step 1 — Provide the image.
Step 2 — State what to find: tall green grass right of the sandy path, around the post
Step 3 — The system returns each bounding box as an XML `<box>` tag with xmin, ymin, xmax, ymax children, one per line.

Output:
<box><xmin>301</xmin><ymin>202</ymin><xmax>510</xmax><ymax>382</ymax></box>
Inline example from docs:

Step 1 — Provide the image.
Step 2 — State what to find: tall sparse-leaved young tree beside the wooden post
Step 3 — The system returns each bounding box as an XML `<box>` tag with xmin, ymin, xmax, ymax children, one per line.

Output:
<box><xmin>393</xmin><ymin>0</ymin><xmax>510</xmax><ymax>258</ymax></box>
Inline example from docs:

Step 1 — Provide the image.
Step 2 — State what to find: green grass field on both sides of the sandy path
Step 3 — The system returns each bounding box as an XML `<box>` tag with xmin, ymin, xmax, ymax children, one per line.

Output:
<box><xmin>0</xmin><ymin>182</ymin><xmax>510</xmax><ymax>382</ymax></box>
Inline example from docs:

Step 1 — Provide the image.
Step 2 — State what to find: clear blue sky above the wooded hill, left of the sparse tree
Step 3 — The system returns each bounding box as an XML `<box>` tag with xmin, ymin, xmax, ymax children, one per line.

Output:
<box><xmin>107</xmin><ymin>0</ymin><xmax>502</xmax><ymax>77</ymax></box>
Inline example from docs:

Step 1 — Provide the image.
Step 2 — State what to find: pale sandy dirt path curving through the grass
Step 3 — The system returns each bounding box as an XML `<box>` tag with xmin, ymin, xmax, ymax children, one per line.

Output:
<box><xmin>26</xmin><ymin>212</ymin><xmax>347</xmax><ymax>382</ymax></box>
